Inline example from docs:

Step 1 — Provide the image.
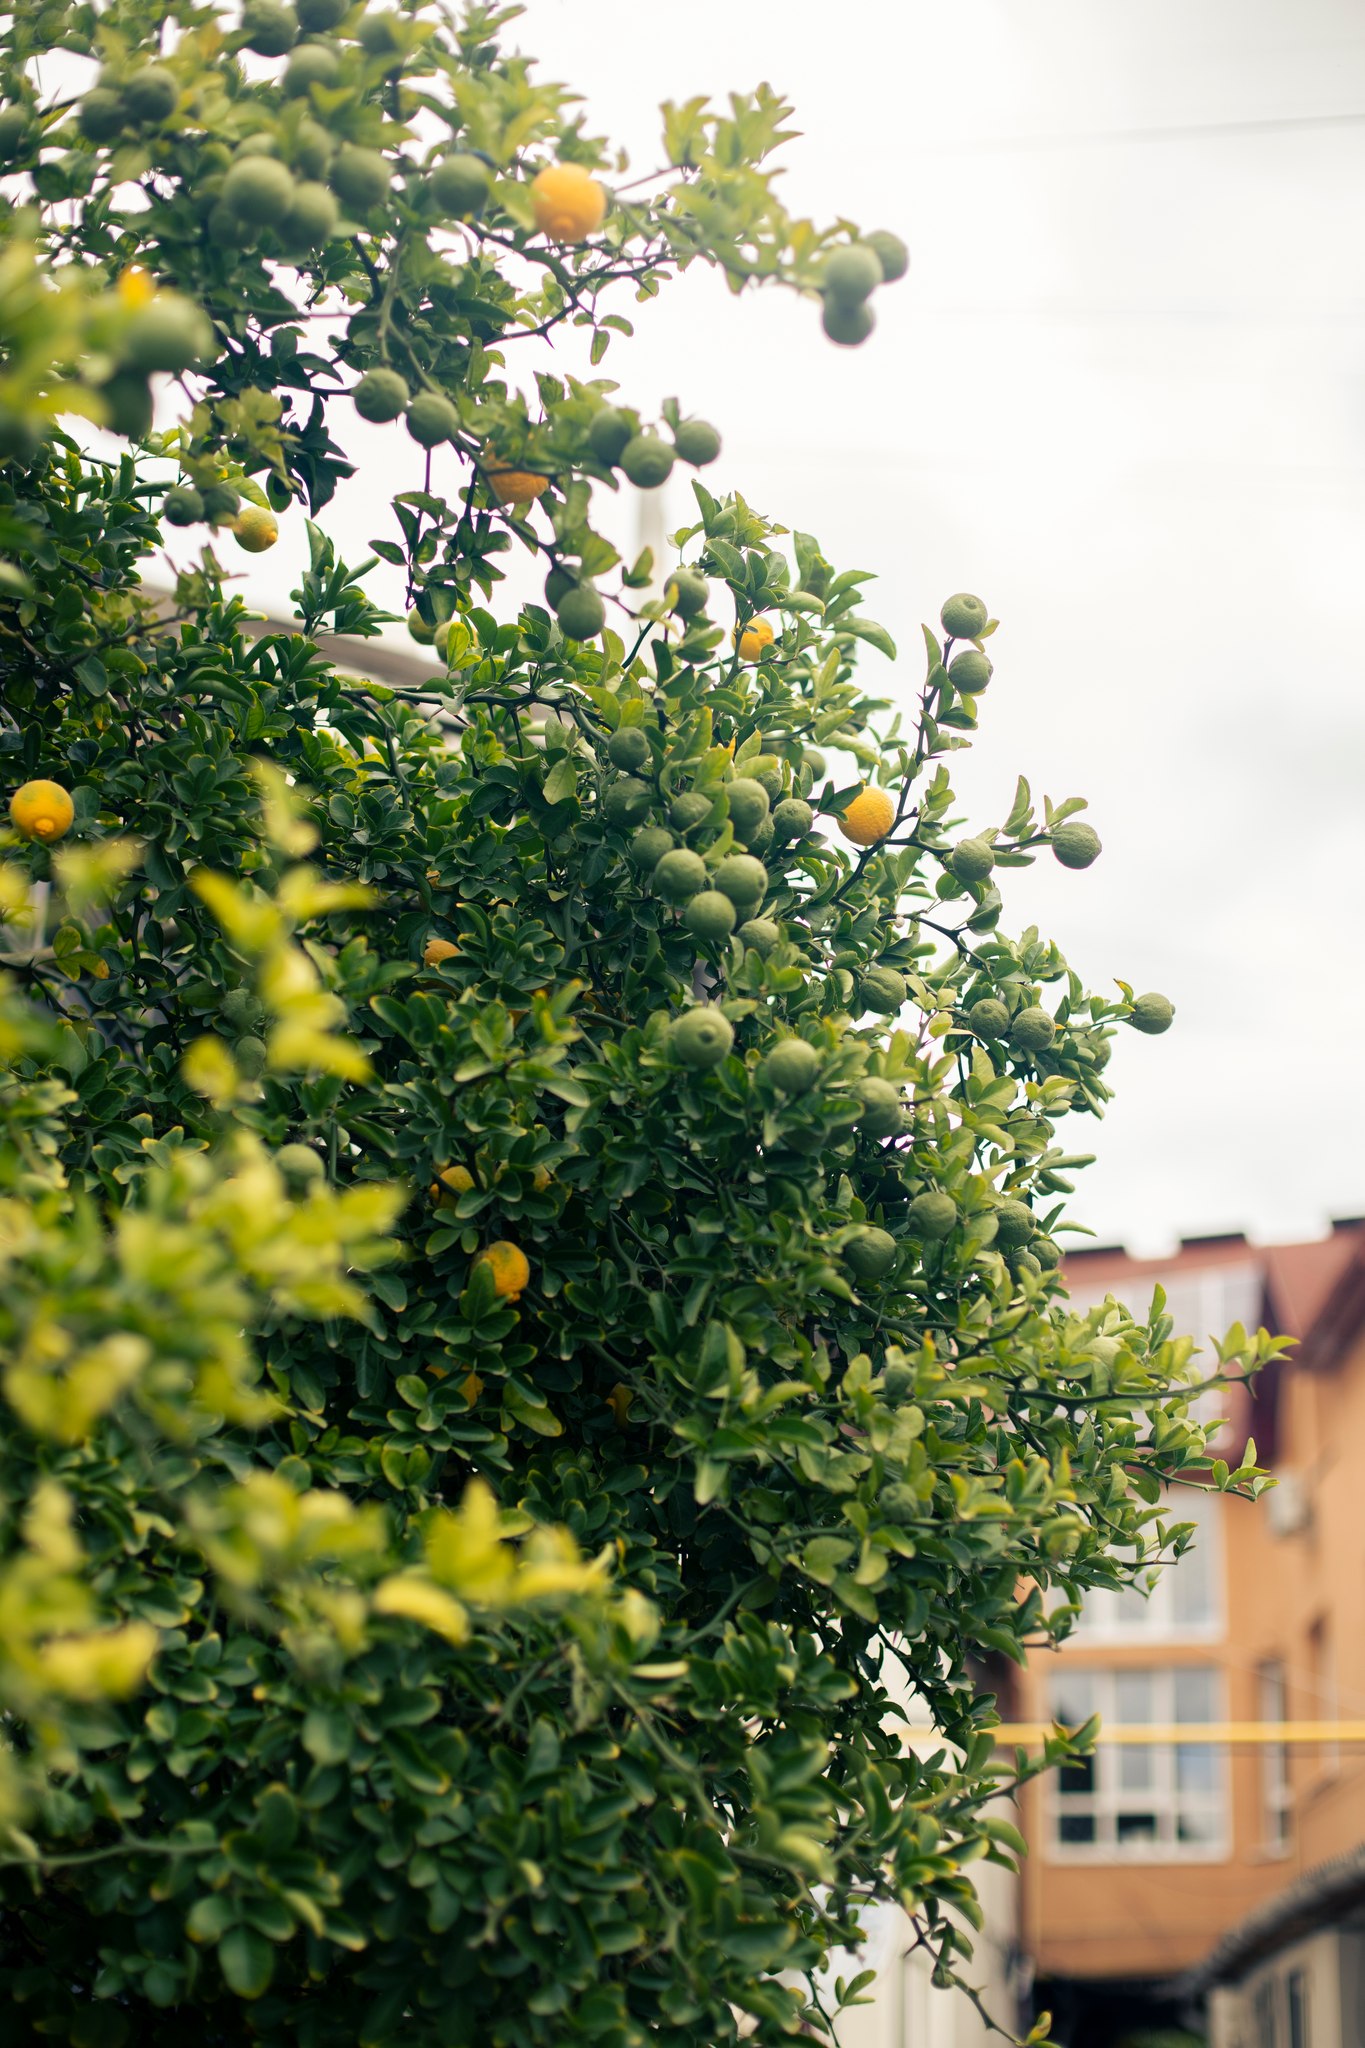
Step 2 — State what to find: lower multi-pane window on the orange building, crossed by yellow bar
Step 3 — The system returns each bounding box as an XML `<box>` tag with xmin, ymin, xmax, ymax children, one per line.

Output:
<box><xmin>1050</xmin><ymin>1665</ymin><xmax>1228</xmax><ymax>1862</ymax></box>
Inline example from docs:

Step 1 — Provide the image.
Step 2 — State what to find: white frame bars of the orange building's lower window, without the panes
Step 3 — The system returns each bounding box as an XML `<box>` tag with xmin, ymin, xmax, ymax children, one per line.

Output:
<box><xmin>1046</xmin><ymin>1665</ymin><xmax>1232</xmax><ymax>1866</ymax></box>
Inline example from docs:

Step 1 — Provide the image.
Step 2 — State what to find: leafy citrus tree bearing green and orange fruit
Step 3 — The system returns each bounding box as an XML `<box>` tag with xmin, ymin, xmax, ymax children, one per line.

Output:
<box><xmin>0</xmin><ymin>0</ymin><xmax>1269</xmax><ymax>2048</ymax></box>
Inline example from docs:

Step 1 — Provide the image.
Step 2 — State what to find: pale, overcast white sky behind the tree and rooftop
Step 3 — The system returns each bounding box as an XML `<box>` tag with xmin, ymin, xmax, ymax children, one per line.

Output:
<box><xmin>213</xmin><ymin>0</ymin><xmax>1365</xmax><ymax>1251</ymax></box>
